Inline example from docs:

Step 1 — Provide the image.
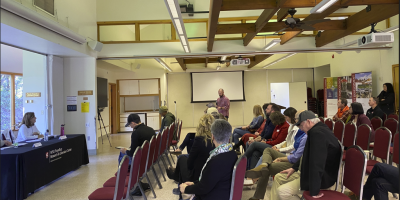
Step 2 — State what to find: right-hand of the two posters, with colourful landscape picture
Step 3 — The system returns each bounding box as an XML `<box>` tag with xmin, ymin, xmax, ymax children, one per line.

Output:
<box><xmin>351</xmin><ymin>72</ymin><xmax>372</xmax><ymax>114</ymax></box>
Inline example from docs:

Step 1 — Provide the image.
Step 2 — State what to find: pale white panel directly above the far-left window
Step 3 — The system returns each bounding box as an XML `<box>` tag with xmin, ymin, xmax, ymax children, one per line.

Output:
<box><xmin>1</xmin><ymin>44</ymin><xmax>23</xmax><ymax>74</ymax></box>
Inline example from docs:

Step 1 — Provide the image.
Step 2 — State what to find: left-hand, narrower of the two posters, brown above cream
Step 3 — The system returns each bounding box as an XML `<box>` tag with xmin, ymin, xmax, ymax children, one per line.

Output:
<box><xmin>324</xmin><ymin>77</ymin><xmax>340</xmax><ymax>118</ymax></box>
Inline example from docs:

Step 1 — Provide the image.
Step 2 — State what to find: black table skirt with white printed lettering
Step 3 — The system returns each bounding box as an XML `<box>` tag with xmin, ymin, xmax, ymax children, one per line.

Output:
<box><xmin>0</xmin><ymin>134</ymin><xmax>89</xmax><ymax>200</ymax></box>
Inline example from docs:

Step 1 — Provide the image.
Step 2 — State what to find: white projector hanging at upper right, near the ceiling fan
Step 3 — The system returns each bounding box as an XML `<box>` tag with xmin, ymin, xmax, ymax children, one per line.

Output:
<box><xmin>358</xmin><ymin>33</ymin><xmax>394</xmax><ymax>47</ymax></box>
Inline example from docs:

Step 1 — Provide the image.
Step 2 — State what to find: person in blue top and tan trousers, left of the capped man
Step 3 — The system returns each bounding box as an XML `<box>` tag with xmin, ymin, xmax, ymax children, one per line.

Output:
<box><xmin>246</xmin><ymin>115</ymin><xmax>307</xmax><ymax>200</ymax></box>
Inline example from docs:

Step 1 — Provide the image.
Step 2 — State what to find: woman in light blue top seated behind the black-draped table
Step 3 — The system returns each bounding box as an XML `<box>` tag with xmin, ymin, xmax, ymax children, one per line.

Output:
<box><xmin>16</xmin><ymin>112</ymin><xmax>40</xmax><ymax>142</ymax></box>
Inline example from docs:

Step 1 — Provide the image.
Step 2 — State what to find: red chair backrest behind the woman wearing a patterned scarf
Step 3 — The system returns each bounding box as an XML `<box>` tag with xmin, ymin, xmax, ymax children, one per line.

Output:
<box><xmin>229</xmin><ymin>155</ymin><xmax>247</xmax><ymax>200</ymax></box>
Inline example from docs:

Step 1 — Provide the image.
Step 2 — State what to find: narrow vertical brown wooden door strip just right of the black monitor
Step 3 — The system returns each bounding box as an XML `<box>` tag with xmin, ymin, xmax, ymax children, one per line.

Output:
<box><xmin>108</xmin><ymin>83</ymin><xmax>118</xmax><ymax>134</ymax></box>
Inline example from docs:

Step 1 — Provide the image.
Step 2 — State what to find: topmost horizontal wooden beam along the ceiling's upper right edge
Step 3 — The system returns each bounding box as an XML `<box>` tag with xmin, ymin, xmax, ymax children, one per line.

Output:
<box><xmin>221</xmin><ymin>0</ymin><xmax>399</xmax><ymax>11</ymax></box>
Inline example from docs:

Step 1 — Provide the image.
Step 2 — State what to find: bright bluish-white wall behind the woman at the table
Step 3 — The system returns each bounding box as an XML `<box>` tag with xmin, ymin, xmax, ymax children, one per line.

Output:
<box><xmin>22</xmin><ymin>51</ymin><xmax>47</xmax><ymax>133</ymax></box>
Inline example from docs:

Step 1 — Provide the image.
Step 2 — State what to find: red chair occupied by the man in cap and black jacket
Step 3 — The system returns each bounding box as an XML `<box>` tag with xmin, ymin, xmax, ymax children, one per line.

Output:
<box><xmin>303</xmin><ymin>146</ymin><xmax>367</xmax><ymax>200</ymax></box>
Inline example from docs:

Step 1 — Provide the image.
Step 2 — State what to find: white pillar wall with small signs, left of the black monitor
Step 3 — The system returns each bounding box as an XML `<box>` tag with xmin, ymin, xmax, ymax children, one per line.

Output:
<box><xmin>64</xmin><ymin>57</ymin><xmax>97</xmax><ymax>154</ymax></box>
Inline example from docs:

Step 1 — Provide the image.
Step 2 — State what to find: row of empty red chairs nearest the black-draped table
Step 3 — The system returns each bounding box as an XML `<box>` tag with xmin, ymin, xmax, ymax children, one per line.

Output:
<box><xmin>88</xmin><ymin>120</ymin><xmax>182</xmax><ymax>200</ymax></box>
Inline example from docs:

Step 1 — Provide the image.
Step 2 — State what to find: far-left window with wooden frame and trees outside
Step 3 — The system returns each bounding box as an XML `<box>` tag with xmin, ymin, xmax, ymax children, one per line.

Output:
<box><xmin>1</xmin><ymin>72</ymin><xmax>24</xmax><ymax>130</ymax></box>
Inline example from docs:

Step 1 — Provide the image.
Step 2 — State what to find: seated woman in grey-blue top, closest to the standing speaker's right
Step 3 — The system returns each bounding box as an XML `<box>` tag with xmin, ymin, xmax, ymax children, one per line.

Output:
<box><xmin>233</xmin><ymin>105</ymin><xmax>264</xmax><ymax>144</ymax></box>
